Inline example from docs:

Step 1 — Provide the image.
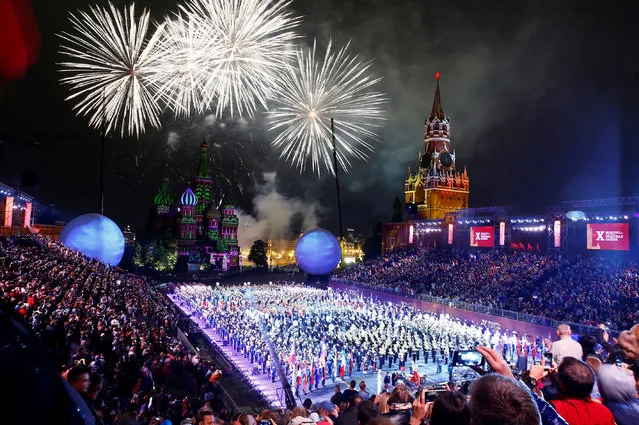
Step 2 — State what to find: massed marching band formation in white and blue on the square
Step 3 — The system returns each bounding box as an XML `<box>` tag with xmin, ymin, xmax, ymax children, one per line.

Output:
<box><xmin>174</xmin><ymin>285</ymin><xmax>544</xmax><ymax>393</ymax></box>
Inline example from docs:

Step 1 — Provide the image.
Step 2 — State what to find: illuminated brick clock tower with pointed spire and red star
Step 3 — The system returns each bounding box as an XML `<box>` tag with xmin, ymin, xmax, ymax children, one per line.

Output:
<box><xmin>404</xmin><ymin>72</ymin><xmax>470</xmax><ymax>220</ymax></box>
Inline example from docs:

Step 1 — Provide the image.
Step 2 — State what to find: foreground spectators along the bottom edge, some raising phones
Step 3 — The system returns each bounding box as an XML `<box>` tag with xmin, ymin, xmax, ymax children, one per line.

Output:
<box><xmin>204</xmin><ymin>339</ymin><xmax>639</xmax><ymax>425</ymax></box>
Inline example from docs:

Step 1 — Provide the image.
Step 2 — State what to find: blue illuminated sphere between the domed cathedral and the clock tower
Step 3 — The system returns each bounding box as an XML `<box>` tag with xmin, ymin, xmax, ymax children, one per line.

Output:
<box><xmin>295</xmin><ymin>228</ymin><xmax>342</xmax><ymax>275</ymax></box>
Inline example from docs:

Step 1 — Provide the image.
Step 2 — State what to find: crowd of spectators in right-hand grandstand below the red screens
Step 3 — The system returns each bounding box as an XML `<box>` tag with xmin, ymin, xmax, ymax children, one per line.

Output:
<box><xmin>339</xmin><ymin>249</ymin><xmax>639</xmax><ymax>329</ymax></box>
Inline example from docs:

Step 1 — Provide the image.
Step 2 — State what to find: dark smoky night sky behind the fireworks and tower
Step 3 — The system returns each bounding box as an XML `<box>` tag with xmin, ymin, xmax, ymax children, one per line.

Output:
<box><xmin>0</xmin><ymin>0</ymin><xmax>639</xmax><ymax>238</ymax></box>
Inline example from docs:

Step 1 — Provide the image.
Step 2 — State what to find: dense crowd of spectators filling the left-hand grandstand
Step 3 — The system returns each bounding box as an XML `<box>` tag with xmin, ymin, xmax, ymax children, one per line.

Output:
<box><xmin>0</xmin><ymin>237</ymin><xmax>230</xmax><ymax>425</ymax></box>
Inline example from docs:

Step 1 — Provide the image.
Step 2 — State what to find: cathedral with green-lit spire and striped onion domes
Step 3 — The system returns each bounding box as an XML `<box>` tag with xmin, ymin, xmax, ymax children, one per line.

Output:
<box><xmin>150</xmin><ymin>141</ymin><xmax>240</xmax><ymax>270</ymax></box>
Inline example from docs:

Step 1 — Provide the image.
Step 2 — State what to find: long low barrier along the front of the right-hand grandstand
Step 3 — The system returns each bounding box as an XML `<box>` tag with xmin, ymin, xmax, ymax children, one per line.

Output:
<box><xmin>332</xmin><ymin>278</ymin><xmax>598</xmax><ymax>335</ymax></box>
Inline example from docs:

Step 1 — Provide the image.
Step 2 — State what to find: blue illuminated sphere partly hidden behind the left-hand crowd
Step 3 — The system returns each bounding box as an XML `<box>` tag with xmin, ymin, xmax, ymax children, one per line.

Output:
<box><xmin>60</xmin><ymin>214</ymin><xmax>124</xmax><ymax>266</ymax></box>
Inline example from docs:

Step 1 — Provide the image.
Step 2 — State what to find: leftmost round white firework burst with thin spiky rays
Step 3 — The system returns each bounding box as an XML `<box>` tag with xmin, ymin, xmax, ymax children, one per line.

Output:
<box><xmin>60</xmin><ymin>3</ymin><xmax>163</xmax><ymax>136</ymax></box>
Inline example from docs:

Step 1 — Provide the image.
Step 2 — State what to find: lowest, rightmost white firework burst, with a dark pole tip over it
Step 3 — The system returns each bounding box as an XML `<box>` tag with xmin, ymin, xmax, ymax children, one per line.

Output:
<box><xmin>267</xmin><ymin>42</ymin><xmax>387</xmax><ymax>175</ymax></box>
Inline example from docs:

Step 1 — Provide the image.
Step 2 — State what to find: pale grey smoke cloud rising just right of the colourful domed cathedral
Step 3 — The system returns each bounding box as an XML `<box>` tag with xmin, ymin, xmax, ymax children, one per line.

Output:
<box><xmin>237</xmin><ymin>172</ymin><xmax>319</xmax><ymax>246</ymax></box>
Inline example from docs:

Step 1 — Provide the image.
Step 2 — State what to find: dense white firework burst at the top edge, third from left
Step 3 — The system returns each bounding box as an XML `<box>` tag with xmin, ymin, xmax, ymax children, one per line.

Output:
<box><xmin>181</xmin><ymin>0</ymin><xmax>300</xmax><ymax>117</ymax></box>
